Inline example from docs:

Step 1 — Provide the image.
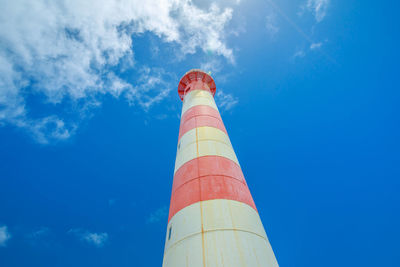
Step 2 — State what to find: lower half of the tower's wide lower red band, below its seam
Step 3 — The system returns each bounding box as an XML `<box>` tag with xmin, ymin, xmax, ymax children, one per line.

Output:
<box><xmin>168</xmin><ymin>176</ymin><xmax>257</xmax><ymax>221</ymax></box>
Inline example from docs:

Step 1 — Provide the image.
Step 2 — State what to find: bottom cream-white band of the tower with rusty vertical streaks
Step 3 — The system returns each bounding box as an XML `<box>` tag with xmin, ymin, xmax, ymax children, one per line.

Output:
<box><xmin>163</xmin><ymin>199</ymin><xmax>278</xmax><ymax>267</ymax></box>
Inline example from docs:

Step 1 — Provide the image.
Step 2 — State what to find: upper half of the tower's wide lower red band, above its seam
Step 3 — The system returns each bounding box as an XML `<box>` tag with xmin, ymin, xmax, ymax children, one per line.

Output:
<box><xmin>172</xmin><ymin>156</ymin><xmax>246</xmax><ymax>193</ymax></box>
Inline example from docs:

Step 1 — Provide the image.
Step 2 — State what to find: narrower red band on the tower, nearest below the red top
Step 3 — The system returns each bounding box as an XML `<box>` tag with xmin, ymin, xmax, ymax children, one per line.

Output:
<box><xmin>178</xmin><ymin>105</ymin><xmax>228</xmax><ymax>141</ymax></box>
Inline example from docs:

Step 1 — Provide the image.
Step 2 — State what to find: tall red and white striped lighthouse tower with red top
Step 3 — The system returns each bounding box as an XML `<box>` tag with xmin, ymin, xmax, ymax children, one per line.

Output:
<box><xmin>163</xmin><ymin>69</ymin><xmax>278</xmax><ymax>267</ymax></box>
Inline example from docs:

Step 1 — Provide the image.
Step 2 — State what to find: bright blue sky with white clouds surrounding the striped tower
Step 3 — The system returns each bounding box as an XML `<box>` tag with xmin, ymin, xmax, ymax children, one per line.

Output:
<box><xmin>0</xmin><ymin>0</ymin><xmax>400</xmax><ymax>267</ymax></box>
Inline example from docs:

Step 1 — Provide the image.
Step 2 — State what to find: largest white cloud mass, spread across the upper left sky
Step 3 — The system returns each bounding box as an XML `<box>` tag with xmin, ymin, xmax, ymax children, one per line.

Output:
<box><xmin>0</xmin><ymin>0</ymin><xmax>234</xmax><ymax>143</ymax></box>
